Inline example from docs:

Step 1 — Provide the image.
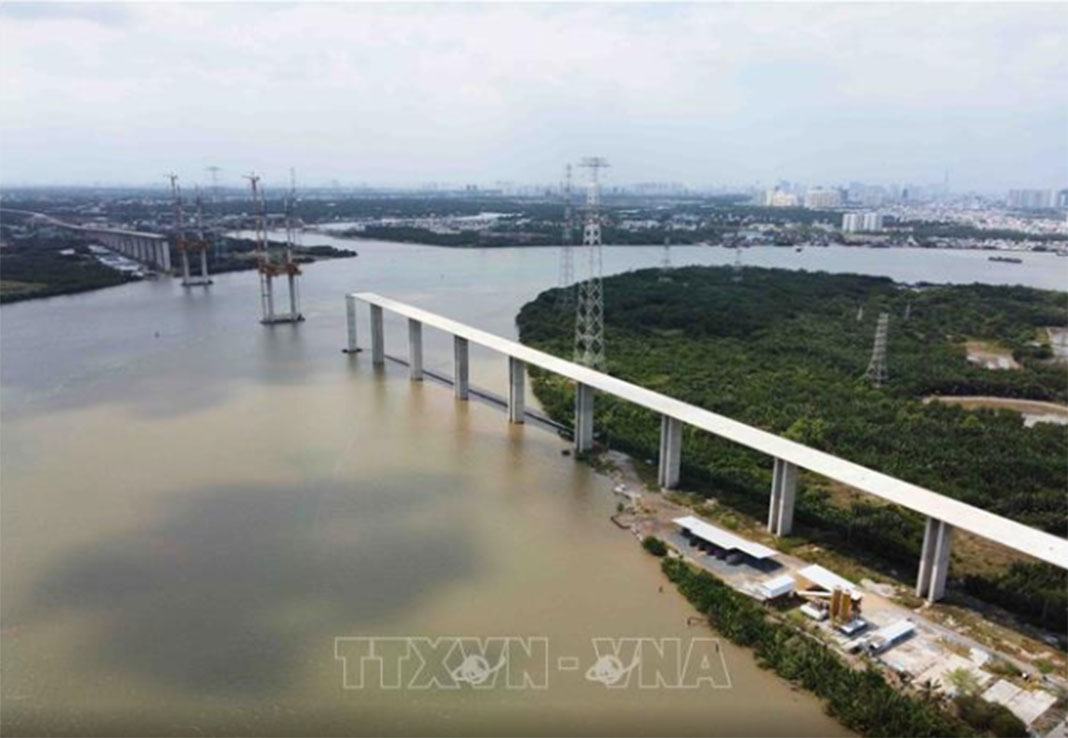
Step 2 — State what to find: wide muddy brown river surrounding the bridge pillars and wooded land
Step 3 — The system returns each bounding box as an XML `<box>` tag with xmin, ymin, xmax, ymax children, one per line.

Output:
<box><xmin>0</xmin><ymin>236</ymin><xmax>1065</xmax><ymax>736</ymax></box>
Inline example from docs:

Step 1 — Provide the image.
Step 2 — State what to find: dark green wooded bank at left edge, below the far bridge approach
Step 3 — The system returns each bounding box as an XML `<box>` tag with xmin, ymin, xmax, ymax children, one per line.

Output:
<box><xmin>0</xmin><ymin>237</ymin><xmax>128</xmax><ymax>302</ymax></box>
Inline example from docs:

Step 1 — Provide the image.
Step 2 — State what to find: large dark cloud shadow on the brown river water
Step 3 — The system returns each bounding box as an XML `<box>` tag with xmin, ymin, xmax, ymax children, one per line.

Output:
<box><xmin>17</xmin><ymin>474</ymin><xmax>477</xmax><ymax>695</ymax></box>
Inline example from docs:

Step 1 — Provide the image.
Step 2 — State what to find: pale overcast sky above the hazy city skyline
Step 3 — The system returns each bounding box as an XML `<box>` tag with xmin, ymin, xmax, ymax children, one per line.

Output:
<box><xmin>0</xmin><ymin>2</ymin><xmax>1068</xmax><ymax>190</ymax></box>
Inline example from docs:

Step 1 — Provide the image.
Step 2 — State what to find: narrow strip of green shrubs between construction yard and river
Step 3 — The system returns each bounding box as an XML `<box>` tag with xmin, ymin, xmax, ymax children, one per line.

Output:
<box><xmin>662</xmin><ymin>559</ymin><xmax>974</xmax><ymax>738</ymax></box>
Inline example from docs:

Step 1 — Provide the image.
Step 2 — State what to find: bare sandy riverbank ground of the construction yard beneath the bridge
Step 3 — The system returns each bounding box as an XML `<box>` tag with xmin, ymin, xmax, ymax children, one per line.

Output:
<box><xmin>591</xmin><ymin>451</ymin><xmax>1068</xmax><ymax>735</ymax></box>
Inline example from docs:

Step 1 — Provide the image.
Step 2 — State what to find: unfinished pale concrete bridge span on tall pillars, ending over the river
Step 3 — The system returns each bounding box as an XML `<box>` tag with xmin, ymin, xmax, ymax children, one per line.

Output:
<box><xmin>345</xmin><ymin>293</ymin><xmax>1068</xmax><ymax>601</ymax></box>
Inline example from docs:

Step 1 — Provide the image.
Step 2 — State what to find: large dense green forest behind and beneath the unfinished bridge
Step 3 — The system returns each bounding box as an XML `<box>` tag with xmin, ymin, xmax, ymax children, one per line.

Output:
<box><xmin>518</xmin><ymin>267</ymin><xmax>1068</xmax><ymax>630</ymax></box>
